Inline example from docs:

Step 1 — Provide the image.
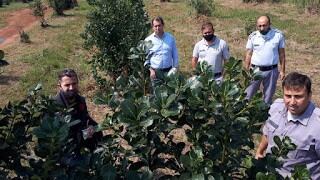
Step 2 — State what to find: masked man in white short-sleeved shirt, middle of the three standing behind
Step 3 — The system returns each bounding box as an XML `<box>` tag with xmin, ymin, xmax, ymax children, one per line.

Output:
<box><xmin>191</xmin><ymin>22</ymin><xmax>230</xmax><ymax>81</ymax></box>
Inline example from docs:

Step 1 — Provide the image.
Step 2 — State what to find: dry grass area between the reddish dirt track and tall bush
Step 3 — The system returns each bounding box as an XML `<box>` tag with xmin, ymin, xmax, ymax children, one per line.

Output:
<box><xmin>2</xmin><ymin>0</ymin><xmax>91</xmax><ymax>103</ymax></box>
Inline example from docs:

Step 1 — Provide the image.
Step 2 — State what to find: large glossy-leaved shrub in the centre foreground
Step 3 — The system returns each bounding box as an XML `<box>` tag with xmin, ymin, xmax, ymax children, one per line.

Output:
<box><xmin>94</xmin><ymin>39</ymin><xmax>268</xmax><ymax>178</ymax></box>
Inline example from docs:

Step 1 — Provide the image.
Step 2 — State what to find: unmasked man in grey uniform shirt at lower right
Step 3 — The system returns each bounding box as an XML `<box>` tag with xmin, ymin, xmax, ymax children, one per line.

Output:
<box><xmin>256</xmin><ymin>72</ymin><xmax>320</xmax><ymax>179</ymax></box>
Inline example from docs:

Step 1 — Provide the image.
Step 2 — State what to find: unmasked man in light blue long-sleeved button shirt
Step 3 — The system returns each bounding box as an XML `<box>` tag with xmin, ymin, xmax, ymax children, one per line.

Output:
<box><xmin>145</xmin><ymin>16</ymin><xmax>179</xmax><ymax>87</ymax></box>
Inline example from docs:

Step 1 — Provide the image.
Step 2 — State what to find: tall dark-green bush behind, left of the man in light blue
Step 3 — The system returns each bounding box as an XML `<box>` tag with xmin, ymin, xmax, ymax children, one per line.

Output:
<box><xmin>82</xmin><ymin>0</ymin><xmax>149</xmax><ymax>87</ymax></box>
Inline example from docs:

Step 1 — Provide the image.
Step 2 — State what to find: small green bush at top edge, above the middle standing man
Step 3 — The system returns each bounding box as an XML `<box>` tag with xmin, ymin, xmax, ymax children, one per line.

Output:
<box><xmin>187</xmin><ymin>0</ymin><xmax>215</xmax><ymax>16</ymax></box>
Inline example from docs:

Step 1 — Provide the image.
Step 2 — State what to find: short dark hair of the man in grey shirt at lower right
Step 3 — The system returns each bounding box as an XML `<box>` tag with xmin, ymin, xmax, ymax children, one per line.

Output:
<box><xmin>282</xmin><ymin>72</ymin><xmax>311</xmax><ymax>94</ymax></box>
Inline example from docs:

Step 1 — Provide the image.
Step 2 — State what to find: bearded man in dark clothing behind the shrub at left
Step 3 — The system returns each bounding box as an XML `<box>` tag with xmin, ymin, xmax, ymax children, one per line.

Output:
<box><xmin>54</xmin><ymin>69</ymin><xmax>103</xmax><ymax>155</ymax></box>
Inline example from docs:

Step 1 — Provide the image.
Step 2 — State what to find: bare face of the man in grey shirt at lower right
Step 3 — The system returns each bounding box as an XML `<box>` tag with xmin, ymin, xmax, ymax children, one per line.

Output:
<box><xmin>283</xmin><ymin>87</ymin><xmax>311</xmax><ymax>116</ymax></box>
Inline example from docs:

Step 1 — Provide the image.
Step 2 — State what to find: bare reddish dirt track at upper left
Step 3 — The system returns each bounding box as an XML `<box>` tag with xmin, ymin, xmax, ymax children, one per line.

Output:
<box><xmin>0</xmin><ymin>9</ymin><xmax>38</xmax><ymax>48</ymax></box>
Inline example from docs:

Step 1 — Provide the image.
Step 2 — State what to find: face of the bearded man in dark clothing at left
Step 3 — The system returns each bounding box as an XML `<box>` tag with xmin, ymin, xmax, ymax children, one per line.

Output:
<box><xmin>59</xmin><ymin>76</ymin><xmax>78</xmax><ymax>97</ymax></box>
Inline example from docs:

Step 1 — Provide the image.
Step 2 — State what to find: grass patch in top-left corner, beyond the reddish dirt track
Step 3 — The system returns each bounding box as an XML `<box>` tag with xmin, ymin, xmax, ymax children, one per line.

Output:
<box><xmin>0</xmin><ymin>2</ymin><xmax>29</xmax><ymax>28</ymax></box>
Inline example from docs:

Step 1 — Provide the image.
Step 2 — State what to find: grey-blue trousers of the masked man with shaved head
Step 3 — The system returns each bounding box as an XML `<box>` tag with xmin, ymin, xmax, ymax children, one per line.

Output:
<box><xmin>246</xmin><ymin>68</ymin><xmax>279</xmax><ymax>104</ymax></box>
